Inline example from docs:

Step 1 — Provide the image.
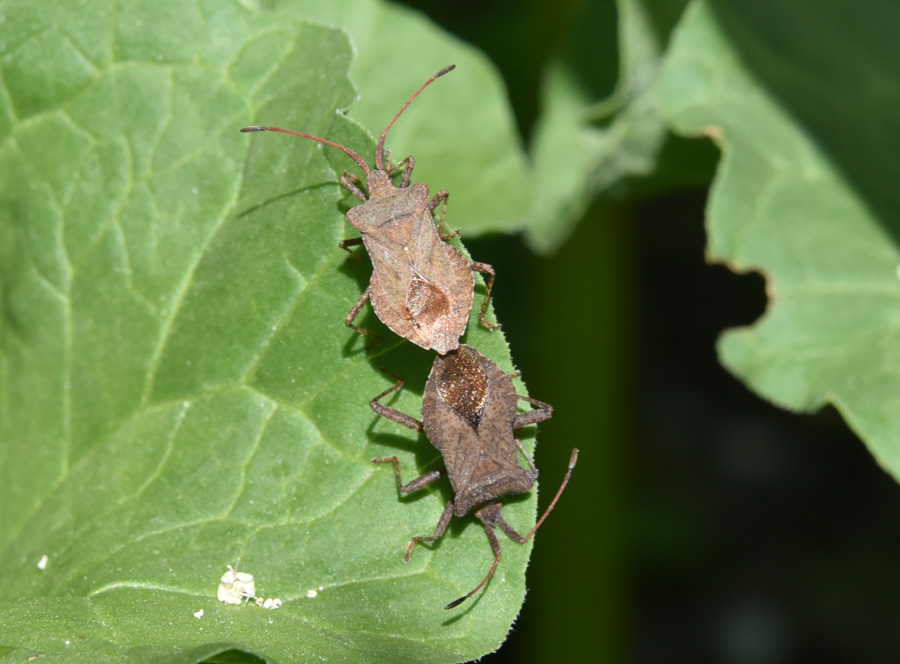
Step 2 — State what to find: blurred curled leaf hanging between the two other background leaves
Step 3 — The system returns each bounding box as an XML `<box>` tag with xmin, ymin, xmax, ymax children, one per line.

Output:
<box><xmin>526</xmin><ymin>0</ymin><xmax>707</xmax><ymax>252</ymax></box>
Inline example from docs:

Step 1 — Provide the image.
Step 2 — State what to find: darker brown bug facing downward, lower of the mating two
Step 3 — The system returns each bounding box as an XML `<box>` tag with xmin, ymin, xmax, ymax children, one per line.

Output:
<box><xmin>370</xmin><ymin>344</ymin><xmax>578</xmax><ymax>609</ymax></box>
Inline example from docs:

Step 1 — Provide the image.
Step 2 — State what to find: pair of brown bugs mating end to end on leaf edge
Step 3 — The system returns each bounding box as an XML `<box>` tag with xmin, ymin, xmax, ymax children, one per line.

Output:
<box><xmin>241</xmin><ymin>65</ymin><xmax>578</xmax><ymax>609</ymax></box>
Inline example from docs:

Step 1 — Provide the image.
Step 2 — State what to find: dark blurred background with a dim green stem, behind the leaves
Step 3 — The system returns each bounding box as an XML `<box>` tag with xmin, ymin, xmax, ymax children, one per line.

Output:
<box><xmin>403</xmin><ymin>0</ymin><xmax>900</xmax><ymax>664</ymax></box>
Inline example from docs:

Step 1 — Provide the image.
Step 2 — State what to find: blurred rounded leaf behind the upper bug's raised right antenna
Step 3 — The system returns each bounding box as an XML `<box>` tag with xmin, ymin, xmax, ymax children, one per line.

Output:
<box><xmin>266</xmin><ymin>0</ymin><xmax>531</xmax><ymax>235</ymax></box>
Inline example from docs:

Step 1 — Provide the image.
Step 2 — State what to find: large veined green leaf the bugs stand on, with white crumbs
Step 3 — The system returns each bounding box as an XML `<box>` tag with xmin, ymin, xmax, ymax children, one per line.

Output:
<box><xmin>0</xmin><ymin>0</ymin><xmax>536</xmax><ymax>662</ymax></box>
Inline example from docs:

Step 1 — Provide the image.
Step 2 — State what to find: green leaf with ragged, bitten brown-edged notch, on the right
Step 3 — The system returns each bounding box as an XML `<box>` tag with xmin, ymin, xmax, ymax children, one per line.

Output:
<box><xmin>658</xmin><ymin>0</ymin><xmax>900</xmax><ymax>478</ymax></box>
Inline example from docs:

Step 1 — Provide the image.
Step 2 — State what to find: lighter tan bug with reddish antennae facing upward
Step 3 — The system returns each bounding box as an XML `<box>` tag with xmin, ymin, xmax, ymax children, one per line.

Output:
<box><xmin>241</xmin><ymin>65</ymin><xmax>499</xmax><ymax>354</ymax></box>
